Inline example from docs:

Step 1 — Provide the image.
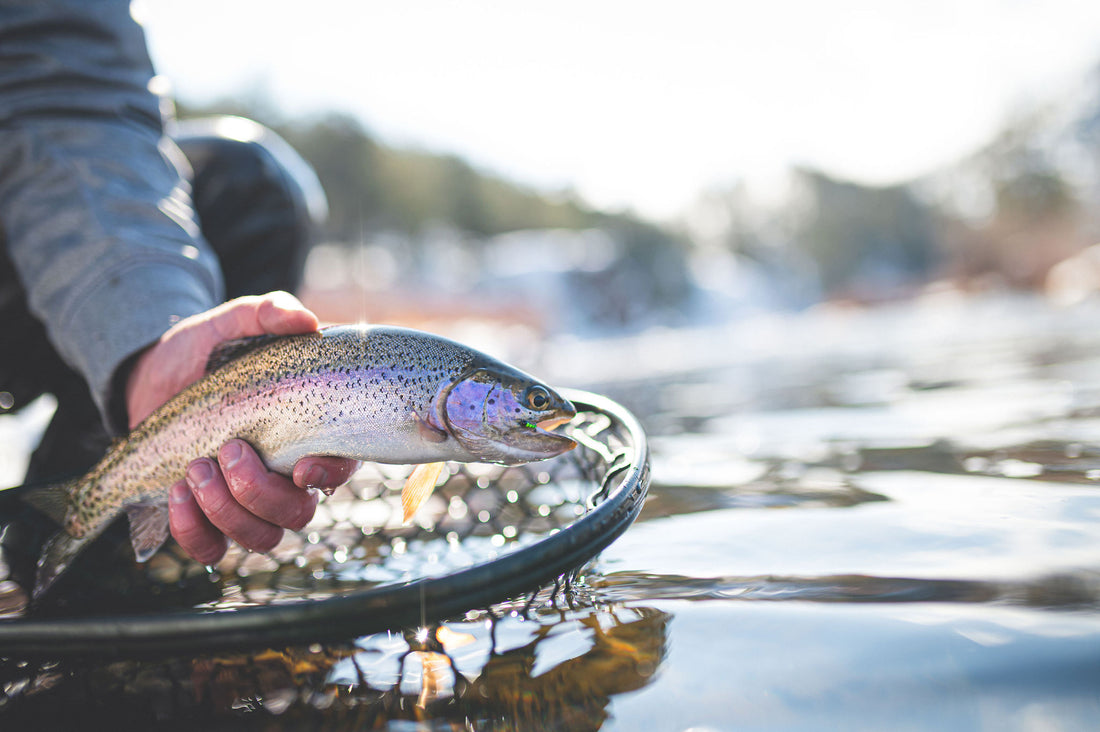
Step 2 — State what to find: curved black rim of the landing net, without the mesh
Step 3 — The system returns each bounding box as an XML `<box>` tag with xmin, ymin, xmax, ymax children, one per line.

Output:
<box><xmin>0</xmin><ymin>390</ymin><xmax>649</xmax><ymax>658</ymax></box>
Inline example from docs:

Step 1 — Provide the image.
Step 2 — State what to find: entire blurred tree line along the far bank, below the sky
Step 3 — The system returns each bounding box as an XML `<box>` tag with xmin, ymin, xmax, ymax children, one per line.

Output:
<box><xmin>182</xmin><ymin>64</ymin><xmax>1100</xmax><ymax>321</ymax></box>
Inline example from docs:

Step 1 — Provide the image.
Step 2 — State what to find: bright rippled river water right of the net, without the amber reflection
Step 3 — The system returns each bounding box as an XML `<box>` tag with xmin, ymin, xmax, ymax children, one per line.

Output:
<box><xmin>554</xmin><ymin>297</ymin><xmax>1100</xmax><ymax>730</ymax></box>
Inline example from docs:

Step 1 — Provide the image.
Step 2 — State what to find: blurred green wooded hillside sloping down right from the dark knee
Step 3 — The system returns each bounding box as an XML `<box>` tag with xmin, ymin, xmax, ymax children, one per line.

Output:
<box><xmin>178</xmin><ymin>100</ymin><xmax>692</xmax><ymax>329</ymax></box>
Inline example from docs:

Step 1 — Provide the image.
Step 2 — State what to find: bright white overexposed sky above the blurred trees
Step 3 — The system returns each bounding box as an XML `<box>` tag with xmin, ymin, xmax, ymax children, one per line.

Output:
<box><xmin>134</xmin><ymin>0</ymin><xmax>1100</xmax><ymax>219</ymax></box>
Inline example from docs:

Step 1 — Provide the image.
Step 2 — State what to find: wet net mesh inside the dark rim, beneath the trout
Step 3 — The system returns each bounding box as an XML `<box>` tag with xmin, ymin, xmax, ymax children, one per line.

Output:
<box><xmin>0</xmin><ymin>393</ymin><xmax>648</xmax><ymax>638</ymax></box>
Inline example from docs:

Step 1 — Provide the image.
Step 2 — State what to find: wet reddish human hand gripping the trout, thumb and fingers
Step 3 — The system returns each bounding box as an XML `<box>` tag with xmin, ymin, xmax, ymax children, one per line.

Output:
<box><xmin>127</xmin><ymin>293</ymin><xmax>359</xmax><ymax>565</ymax></box>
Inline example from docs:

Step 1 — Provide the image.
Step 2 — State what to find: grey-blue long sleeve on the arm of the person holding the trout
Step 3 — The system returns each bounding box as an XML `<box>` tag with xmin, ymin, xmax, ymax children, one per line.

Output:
<box><xmin>0</xmin><ymin>0</ymin><xmax>223</xmax><ymax>429</ymax></box>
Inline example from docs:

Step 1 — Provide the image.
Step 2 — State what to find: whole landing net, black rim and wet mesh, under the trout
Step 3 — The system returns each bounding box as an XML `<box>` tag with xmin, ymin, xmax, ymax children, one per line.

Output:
<box><xmin>0</xmin><ymin>391</ymin><xmax>649</xmax><ymax>658</ymax></box>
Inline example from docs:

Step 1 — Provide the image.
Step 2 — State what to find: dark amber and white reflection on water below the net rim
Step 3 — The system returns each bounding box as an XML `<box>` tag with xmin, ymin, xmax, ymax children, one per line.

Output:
<box><xmin>0</xmin><ymin>607</ymin><xmax>671</xmax><ymax>731</ymax></box>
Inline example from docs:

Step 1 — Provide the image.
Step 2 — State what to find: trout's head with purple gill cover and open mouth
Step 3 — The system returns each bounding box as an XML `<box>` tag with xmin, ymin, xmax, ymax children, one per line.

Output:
<box><xmin>437</xmin><ymin>363</ymin><xmax>576</xmax><ymax>465</ymax></box>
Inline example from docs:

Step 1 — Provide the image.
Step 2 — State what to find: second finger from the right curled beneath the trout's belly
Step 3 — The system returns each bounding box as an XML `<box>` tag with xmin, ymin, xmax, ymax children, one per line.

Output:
<box><xmin>218</xmin><ymin>439</ymin><xmax>317</xmax><ymax>529</ymax></box>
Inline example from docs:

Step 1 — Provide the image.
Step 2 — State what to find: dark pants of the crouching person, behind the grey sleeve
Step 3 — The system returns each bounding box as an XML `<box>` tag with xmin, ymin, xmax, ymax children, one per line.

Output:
<box><xmin>0</xmin><ymin>118</ymin><xmax>323</xmax><ymax>483</ymax></box>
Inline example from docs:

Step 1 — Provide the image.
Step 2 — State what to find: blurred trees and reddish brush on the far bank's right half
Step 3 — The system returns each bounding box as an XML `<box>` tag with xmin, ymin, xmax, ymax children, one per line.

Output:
<box><xmin>686</xmin><ymin>69</ymin><xmax>1100</xmax><ymax>303</ymax></box>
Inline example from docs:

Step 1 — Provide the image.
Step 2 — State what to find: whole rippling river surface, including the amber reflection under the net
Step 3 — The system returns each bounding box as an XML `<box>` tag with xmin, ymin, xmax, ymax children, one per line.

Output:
<box><xmin>0</xmin><ymin>290</ymin><xmax>1100</xmax><ymax>731</ymax></box>
